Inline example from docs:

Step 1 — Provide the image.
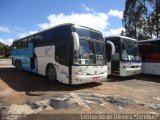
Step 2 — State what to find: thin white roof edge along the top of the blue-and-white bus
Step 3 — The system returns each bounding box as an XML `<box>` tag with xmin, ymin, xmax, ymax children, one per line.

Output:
<box><xmin>13</xmin><ymin>23</ymin><xmax>102</xmax><ymax>42</ymax></box>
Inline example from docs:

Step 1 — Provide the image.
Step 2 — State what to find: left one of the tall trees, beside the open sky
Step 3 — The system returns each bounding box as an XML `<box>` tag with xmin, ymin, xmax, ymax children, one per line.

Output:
<box><xmin>122</xmin><ymin>0</ymin><xmax>145</xmax><ymax>38</ymax></box>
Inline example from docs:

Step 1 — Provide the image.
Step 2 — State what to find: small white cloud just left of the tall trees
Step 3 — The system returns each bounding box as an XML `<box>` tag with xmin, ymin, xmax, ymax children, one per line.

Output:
<box><xmin>108</xmin><ymin>9</ymin><xmax>123</xmax><ymax>19</ymax></box>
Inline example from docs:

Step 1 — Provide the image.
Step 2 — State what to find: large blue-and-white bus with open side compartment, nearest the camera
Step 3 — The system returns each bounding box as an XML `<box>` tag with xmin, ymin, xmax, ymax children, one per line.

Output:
<box><xmin>12</xmin><ymin>23</ymin><xmax>107</xmax><ymax>84</ymax></box>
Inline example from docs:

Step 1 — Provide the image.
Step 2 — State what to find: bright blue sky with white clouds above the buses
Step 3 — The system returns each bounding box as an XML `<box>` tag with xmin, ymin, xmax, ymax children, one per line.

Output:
<box><xmin>0</xmin><ymin>0</ymin><xmax>125</xmax><ymax>45</ymax></box>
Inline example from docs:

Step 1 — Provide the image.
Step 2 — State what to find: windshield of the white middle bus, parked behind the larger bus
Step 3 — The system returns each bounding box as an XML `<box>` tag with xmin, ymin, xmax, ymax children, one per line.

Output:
<box><xmin>122</xmin><ymin>39</ymin><xmax>140</xmax><ymax>61</ymax></box>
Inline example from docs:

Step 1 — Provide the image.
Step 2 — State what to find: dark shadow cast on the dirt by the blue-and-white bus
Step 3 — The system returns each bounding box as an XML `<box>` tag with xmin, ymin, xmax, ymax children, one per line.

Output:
<box><xmin>0</xmin><ymin>68</ymin><xmax>101</xmax><ymax>93</ymax></box>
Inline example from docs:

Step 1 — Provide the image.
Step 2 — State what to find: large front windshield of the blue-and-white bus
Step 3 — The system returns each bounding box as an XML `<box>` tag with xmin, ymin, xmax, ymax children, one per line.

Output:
<box><xmin>73</xmin><ymin>27</ymin><xmax>105</xmax><ymax>65</ymax></box>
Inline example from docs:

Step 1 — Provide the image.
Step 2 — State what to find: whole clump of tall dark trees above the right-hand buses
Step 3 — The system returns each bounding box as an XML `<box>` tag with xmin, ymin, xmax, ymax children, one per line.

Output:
<box><xmin>122</xmin><ymin>0</ymin><xmax>160</xmax><ymax>40</ymax></box>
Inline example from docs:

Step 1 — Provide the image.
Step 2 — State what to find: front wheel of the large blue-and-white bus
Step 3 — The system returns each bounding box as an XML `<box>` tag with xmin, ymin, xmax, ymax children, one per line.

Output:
<box><xmin>46</xmin><ymin>65</ymin><xmax>56</xmax><ymax>82</ymax></box>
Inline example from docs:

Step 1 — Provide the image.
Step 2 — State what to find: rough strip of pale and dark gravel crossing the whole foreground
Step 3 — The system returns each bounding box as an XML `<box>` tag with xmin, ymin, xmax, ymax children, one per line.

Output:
<box><xmin>0</xmin><ymin>93</ymin><xmax>160</xmax><ymax>120</ymax></box>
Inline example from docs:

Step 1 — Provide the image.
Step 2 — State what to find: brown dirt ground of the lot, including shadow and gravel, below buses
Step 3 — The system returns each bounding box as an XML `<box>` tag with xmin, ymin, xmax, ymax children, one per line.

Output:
<box><xmin>0</xmin><ymin>59</ymin><xmax>160</xmax><ymax>119</ymax></box>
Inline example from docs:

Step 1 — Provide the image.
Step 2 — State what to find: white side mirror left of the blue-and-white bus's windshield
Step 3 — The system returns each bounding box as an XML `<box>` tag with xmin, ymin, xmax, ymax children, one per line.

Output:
<box><xmin>72</xmin><ymin>32</ymin><xmax>80</xmax><ymax>51</ymax></box>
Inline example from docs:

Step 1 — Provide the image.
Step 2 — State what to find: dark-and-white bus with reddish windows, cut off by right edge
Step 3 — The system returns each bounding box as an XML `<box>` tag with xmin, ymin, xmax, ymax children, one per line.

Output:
<box><xmin>138</xmin><ymin>38</ymin><xmax>160</xmax><ymax>75</ymax></box>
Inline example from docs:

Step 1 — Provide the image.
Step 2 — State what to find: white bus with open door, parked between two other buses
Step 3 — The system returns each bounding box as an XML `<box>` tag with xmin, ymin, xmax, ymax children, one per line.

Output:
<box><xmin>105</xmin><ymin>36</ymin><xmax>142</xmax><ymax>76</ymax></box>
